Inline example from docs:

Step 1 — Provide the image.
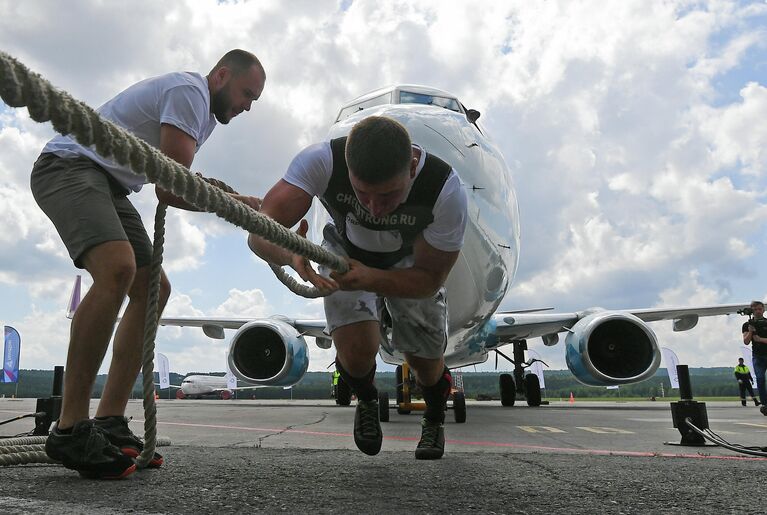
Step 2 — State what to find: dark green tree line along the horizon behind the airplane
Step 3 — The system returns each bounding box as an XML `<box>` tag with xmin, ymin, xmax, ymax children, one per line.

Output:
<box><xmin>0</xmin><ymin>367</ymin><xmax>738</xmax><ymax>399</ymax></box>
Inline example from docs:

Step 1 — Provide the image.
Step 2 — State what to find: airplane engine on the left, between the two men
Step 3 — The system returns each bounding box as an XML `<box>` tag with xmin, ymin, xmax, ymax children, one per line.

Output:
<box><xmin>229</xmin><ymin>318</ymin><xmax>309</xmax><ymax>386</ymax></box>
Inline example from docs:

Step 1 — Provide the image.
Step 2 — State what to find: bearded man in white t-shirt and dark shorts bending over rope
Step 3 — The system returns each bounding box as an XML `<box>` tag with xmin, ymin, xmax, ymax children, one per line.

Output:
<box><xmin>30</xmin><ymin>50</ymin><xmax>266</xmax><ymax>479</ymax></box>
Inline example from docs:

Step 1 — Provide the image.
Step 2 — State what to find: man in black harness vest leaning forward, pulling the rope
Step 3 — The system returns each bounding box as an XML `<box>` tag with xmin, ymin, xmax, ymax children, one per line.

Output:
<box><xmin>248</xmin><ymin>116</ymin><xmax>467</xmax><ymax>459</ymax></box>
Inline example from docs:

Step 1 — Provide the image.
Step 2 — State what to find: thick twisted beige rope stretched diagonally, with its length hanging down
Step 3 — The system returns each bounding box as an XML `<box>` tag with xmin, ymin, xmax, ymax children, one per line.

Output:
<box><xmin>0</xmin><ymin>52</ymin><xmax>348</xmax><ymax>467</ymax></box>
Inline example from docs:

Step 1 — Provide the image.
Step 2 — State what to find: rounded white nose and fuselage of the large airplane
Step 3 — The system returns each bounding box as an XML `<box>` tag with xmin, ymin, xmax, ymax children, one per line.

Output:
<box><xmin>314</xmin><ymin>86</ymin><xmax>520</xmax><ymax>368</ymax></box>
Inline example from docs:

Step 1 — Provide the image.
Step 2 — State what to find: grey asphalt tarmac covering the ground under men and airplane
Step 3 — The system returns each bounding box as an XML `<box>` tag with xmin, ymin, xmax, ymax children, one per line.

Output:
<box><xmin>0</xmin><ymin>398</ymin><xmax>767</xmax><ymax>515</ymax></box>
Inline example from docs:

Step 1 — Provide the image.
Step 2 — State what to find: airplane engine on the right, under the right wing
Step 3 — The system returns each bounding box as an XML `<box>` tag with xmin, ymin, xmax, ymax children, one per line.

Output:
<box><xmin>565</xmin><ymin>311</ymin><xmax>661</xmax><ymax>386</ymax></box>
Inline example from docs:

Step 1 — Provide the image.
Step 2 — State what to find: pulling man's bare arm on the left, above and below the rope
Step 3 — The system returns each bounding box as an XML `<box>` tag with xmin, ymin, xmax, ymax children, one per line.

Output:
<box><xmin>248</xmin><ymin>179</ymin><xmax>312</xmax><ymax>266</ymax></box>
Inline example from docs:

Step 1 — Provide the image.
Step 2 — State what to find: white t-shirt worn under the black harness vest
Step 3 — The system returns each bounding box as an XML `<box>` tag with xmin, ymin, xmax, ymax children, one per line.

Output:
<box><xmin>283</xmin><ymin>141</ymin><xmax>467</xmax><ymax>252</ymax></box>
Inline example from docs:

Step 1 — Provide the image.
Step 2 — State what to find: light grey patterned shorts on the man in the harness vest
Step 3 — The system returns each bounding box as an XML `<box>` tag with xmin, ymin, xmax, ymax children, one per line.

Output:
<box><xmin>319</xmin><ymin>224</ymin><xmax>448</xmax><ymax>359</ymax></box>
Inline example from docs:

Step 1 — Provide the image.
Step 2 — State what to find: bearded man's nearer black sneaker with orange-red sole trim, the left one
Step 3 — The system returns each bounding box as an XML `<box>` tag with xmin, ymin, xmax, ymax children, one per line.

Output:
<box><xmin>45</xmin><ymin>420</ymin><xmax>136</xmax><ymax>479</ymax></box>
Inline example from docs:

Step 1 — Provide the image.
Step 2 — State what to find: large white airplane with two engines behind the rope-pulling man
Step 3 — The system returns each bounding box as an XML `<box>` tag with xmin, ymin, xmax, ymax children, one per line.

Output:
<box><xmin>141</xmin><ymin>84</ymin><xmax>745</xmax><ymax>422</ymax></box>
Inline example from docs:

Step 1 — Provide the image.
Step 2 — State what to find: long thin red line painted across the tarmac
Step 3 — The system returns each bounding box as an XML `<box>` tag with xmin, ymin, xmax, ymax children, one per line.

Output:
<box><xmin>141</xmin><ymin>418</ymin><xmax>767</xmax><ymax>461</ymax></box>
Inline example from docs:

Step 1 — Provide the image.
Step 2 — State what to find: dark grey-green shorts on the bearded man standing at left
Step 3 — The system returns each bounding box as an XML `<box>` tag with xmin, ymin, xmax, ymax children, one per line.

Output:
<box><xmin>30</xmin><ymin>154</ymin><xmax>152</xmax><ymax>268</ymax></box>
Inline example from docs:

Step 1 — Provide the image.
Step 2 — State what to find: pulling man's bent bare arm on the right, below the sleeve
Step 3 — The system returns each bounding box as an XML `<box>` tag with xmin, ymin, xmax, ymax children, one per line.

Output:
<box><xmin>331</xmin><ymin>236</ymin><xmax>460</xmax><ymax>299</ymax></box>
